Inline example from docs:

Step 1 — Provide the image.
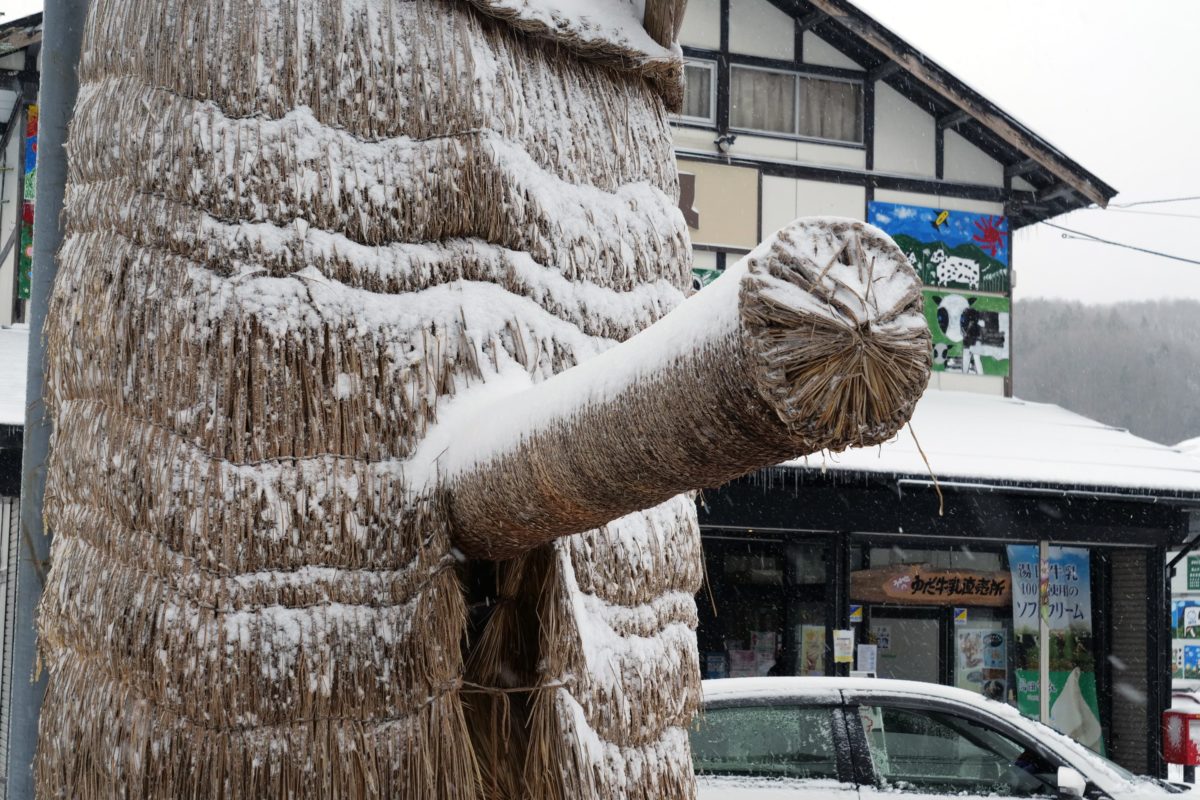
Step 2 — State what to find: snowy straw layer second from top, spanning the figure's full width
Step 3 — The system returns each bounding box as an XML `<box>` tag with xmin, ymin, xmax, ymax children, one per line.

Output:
<box><xmin>71</xmin><ymin>82</ymin><xmax>689</xmax><ymax>289</ymax></box>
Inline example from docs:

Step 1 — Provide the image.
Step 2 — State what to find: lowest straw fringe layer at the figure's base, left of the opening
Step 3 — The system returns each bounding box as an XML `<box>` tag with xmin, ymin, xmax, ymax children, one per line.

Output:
<box><xmin>35</xmin><ymin>671</ymin><xmax>479</xmax><ymax>800</ymax></box>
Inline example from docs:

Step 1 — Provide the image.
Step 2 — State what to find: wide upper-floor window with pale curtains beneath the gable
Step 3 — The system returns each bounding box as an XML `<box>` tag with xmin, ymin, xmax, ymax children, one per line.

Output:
<box><xmin>730</xmin><ymin>64</ymin><xmax>863</xmax><ymax>144</ymax></box>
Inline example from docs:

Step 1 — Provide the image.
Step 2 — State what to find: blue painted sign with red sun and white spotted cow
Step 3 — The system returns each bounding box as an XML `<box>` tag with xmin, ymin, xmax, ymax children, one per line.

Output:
<box><xmin>866</xmin><ymin>203</ymin><xmax>1010</xmax><ymax>294</ymax></box>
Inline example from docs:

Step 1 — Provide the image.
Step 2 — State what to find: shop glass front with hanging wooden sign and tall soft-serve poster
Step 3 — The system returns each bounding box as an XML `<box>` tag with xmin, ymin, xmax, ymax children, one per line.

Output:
<box><xmin>850</xmin><ymin>541</ymin><xmax>1103</xmax><ymax>748</ymax></box>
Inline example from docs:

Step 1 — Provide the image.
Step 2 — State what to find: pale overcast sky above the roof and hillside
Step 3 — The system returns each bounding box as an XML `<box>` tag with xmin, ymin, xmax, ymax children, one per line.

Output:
<box><xmin>9</xmin><ymin>0</ymin><xmax>1200</xmax><ymax>302</ymax></box>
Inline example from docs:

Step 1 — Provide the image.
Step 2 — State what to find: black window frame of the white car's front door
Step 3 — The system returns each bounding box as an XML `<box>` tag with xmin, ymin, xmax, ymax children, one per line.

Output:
<box><xmin>844</xmin><ymin>692</ymin><xmax>1080</xmax><ymax>798</ymax></box>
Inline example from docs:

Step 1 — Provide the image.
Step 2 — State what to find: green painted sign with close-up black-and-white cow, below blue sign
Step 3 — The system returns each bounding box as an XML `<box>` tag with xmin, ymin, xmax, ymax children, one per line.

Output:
<box><xmin>924</xmin><ymin>289</ymin><xmax>1012</xmax><ymax>375</ymax></box>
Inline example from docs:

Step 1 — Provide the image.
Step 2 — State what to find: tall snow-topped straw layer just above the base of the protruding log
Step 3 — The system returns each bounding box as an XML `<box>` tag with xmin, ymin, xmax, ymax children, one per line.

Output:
<box><xmin>47</xmin><ymin>241</ymin><xmax>600</xmax><ymax>463</ymax></box>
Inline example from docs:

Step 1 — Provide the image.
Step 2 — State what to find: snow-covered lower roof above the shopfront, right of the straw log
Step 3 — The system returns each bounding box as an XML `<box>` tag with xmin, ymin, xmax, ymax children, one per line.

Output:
<box><xmin>790</xmin><ymin>390</ymin><xmax>1200</xmax><ymax>499</ymax></box>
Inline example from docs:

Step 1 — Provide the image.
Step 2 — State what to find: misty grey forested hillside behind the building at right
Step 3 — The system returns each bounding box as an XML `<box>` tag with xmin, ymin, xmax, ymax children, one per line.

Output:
<box><xmin>1013</xmin><ymin>300</ymin><xmax>1200</xmax><ymax>444</ymax></box>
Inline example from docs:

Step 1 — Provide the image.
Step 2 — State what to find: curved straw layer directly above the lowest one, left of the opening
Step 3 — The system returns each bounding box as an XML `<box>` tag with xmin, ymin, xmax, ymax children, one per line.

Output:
<box><xmin>40</xmin><ymin>537</ymin><xmax>466</xmax><ymax>728</ymax></box>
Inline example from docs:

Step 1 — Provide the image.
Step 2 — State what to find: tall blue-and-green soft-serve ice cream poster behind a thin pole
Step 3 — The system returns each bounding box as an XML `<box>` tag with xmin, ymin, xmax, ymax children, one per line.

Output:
<box><xmin>1008</xmin><ymin>545</ymin><xmax>1104</xmax><ymax>752</ymax></box>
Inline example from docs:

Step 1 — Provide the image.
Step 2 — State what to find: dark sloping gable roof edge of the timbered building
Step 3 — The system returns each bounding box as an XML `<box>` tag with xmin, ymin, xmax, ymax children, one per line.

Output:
<box><xmin>770</xmin><ymin>0</ymin><xmax>1117</xmax><ymax>229</ymax></box>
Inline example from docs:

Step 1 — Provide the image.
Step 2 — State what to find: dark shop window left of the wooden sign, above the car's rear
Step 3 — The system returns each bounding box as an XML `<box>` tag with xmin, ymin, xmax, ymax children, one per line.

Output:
<box><xmin>696</xmin><ymin>531</ymin><xmax>833</xmax><ymax>678</ymax></box>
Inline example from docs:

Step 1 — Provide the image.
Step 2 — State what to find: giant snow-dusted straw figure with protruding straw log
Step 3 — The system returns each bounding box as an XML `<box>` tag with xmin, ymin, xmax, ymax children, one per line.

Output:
<box><xmin>36</xmin><ymin>0</ymin><xmax>929</xmax><ymax>800</ymax></box>
